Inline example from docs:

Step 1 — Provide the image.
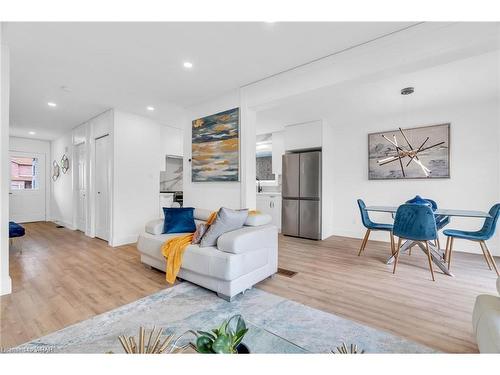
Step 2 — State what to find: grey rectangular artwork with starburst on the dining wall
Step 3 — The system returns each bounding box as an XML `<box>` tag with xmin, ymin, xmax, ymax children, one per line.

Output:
<box><xmin>368</xmin><ymin>124</ymin><xmax>450</xmax><ymax>180</ymax></box>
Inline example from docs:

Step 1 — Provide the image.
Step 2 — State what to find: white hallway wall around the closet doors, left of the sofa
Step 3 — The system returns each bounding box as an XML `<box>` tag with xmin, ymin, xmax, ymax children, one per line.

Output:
<box><xmin>47</xmin><ymin>110</ymin><xmax>183</xmax><ymax>246</ymax></box>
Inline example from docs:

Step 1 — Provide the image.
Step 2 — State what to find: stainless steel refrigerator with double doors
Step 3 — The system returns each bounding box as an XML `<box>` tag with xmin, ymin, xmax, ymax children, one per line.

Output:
<box><xmin>281</xmin><ymin>151</ymin><xmax>321</xmax><ymax>240</ymax></box>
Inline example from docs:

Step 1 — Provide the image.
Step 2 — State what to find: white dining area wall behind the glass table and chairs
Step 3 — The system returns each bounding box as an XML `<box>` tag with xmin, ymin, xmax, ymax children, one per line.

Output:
<box><xmin>324</xmin><ymin>98</ymin><xmax>500</xmax><ymax>255</ymax></box>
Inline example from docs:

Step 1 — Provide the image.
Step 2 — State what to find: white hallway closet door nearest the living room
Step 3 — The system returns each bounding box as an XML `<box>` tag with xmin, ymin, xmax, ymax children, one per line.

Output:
<box><xmin>95</xmin><ymin>136</ymin><xmax>110</xmax><ymax>241</ymax></box>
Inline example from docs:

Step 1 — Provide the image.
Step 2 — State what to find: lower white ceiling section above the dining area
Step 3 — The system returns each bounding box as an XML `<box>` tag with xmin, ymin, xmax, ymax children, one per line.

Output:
<box><xmin>257</xmin><ymin>50</ymin><xmax>500</xmax><ymax>134</ymax></box>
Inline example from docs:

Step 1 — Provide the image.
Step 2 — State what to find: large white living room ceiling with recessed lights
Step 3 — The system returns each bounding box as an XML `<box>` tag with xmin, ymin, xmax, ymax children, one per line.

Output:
<box><xmin>4</xmin><ymin>22</ymin><xmax>418</xmax><ymax>139</ymax></box>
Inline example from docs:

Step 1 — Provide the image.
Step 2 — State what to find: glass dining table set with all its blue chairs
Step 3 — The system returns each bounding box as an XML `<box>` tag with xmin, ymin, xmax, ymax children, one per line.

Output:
<box><xmin>357</xmin><ymin>195</ymin><xmax>500</xmax><ymax>281</ymax></box>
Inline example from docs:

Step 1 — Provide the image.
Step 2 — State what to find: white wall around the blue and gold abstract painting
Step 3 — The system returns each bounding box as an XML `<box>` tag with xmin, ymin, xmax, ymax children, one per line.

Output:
<box><xmin>183</xmin><ymin>91</ymin><xmax>243</xmax><ymax>210</ymax></box>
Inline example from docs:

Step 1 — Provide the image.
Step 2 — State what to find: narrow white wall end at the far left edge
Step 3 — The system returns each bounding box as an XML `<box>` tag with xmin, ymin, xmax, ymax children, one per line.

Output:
<box><xmin>0</xmin><ymin>30</ymin><xmax>12</xmax><ymax>295</ymax></box>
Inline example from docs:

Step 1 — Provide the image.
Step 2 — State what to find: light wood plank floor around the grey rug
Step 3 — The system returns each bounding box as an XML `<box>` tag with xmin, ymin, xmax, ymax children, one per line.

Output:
<box><xmin>0</xmin><ymin>223</ymin><xmax>500</xmax><ymax>352</ymax></box>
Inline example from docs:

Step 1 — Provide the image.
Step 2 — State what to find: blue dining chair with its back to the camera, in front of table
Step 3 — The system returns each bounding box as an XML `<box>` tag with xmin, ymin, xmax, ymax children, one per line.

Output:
<box><xmin>392</xmin><ymin>203</ymin><xmax>437</xmax><ymax>281</ymax></box>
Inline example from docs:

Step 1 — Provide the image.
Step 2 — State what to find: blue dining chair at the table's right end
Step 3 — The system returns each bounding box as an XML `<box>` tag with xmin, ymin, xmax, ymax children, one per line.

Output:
<box><xmin>443</xmin><ymin>203</ymin><xmax>500</xmax><ymax>276</ymax></box>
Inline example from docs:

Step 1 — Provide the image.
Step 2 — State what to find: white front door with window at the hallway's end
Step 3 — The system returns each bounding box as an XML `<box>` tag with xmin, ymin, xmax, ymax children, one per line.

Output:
<box><xmin>9</xmin><ymin>152</ymin><xmax>46</xmax><ymax>223</ymax></box>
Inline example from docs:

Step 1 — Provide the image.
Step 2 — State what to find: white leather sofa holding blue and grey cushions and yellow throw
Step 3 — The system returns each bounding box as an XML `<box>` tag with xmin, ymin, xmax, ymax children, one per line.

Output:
<box><xmin>137</xmin><ymin>209</ymin><xmax>278</xmax><ymax>301</ymax></box>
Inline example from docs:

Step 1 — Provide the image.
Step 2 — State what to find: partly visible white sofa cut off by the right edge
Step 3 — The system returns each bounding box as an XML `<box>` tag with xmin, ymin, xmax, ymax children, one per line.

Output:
<box><xmin>472</xmin><ymin>277</ymin><xmax>500</xmax><ymax>353</ymax></box>
